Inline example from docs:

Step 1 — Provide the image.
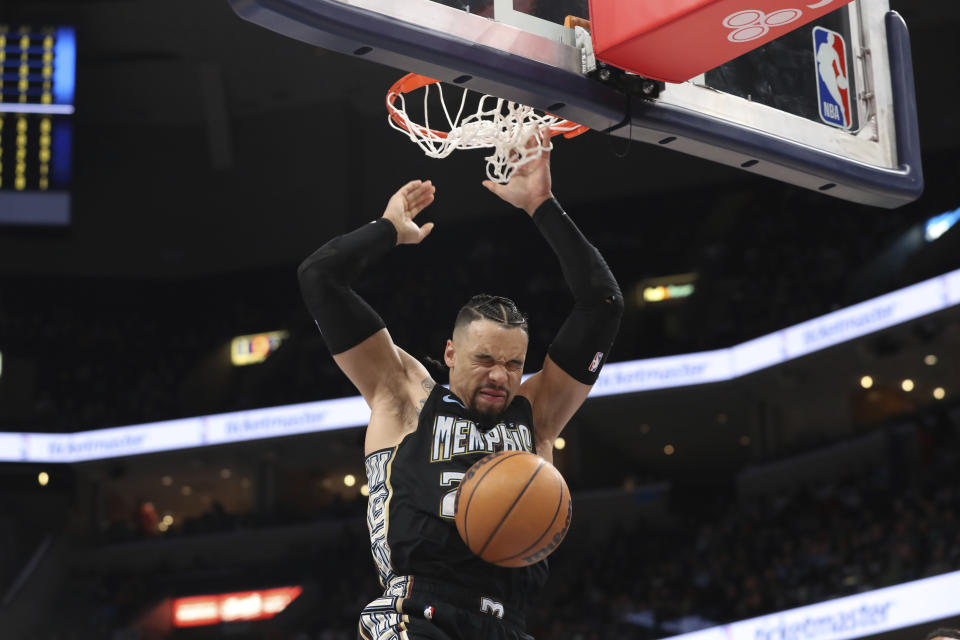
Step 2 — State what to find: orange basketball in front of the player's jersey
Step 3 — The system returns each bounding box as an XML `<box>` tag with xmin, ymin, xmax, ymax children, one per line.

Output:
<box><xmin>456</xmin><ymin>451</ymin><xmax>573</xmax><ymax>567</ymax></box>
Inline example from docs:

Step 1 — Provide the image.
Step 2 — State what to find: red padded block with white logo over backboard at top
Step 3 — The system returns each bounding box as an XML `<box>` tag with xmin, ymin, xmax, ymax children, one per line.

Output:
<box><xmin>590</xmin><ymin>0</ymin><xmax>850</xmax><ymax>82</ymax></box>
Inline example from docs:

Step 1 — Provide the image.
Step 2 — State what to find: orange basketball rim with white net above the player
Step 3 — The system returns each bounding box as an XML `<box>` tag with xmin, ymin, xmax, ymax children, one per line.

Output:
<box><xmin>387</xmin><ymin>73</ymin><xmax>588</xmax><ymax>184</ymax></box>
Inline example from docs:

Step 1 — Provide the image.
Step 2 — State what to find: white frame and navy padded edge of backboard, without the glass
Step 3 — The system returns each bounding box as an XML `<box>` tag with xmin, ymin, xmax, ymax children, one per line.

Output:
<box><xmin>229</xmin><ymin>0</ymin><xmax>923</xmax><ymax>208</ymax></box>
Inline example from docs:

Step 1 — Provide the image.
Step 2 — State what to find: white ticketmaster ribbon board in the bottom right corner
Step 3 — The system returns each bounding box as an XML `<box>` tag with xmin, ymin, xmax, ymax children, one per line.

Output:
<box><xmin>664</xmin><ymin>571</ymin><xmax>960</xmax><ymax>640</ymax></box>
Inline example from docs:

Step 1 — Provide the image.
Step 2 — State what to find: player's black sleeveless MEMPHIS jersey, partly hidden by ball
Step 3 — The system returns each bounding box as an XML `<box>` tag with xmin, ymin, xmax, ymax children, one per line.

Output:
<box><xmin>366</xmin><ymin>385</ymin><xmax>547</xmax><ymax>608</ymax></box>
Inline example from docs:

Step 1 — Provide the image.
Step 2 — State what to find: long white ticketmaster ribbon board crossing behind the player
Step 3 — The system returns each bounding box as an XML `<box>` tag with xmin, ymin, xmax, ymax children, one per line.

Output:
<box><xmin>0</xmin><ymin>262</ymin><xmax>960</xmax><ymax>462</ymax></box>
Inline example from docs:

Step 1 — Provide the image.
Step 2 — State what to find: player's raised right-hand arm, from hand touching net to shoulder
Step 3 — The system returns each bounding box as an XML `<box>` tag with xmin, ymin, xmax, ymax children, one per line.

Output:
<box><xmin>483</xmin><ymin>148</ymin><xmax>623</xmax><ymax>454</ymax></box>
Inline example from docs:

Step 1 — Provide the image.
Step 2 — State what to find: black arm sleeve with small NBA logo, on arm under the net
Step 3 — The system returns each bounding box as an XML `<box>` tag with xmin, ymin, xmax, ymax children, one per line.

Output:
<box><xmin>533</xmin><ymin>198</ymin><xmax>623</xmax><ymax>385</ymax></box>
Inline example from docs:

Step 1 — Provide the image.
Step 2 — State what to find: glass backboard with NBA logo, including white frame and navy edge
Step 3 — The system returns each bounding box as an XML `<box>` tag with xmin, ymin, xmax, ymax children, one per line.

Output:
<box><xmin>229</xmin><ymin>0</ymin><xmax>923</xmax><ymax>208</ymax></box>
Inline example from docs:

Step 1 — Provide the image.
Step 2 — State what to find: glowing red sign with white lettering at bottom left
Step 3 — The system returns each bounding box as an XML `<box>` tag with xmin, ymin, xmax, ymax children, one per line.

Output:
<box><xmin>173</xmin><ymin>586</ymin><xmax>303</xmax><ymax>627</ymax></box>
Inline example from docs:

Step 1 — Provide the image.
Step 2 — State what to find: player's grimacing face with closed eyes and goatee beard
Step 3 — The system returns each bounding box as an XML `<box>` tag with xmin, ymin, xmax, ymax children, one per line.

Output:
<box><xmin>444</xmin><ymin>320</ymin><xmax>527</xmax><ymax>418</ymax></box>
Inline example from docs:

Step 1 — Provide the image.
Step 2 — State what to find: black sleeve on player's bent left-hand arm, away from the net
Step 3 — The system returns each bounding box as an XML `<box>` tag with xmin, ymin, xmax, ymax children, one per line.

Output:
<box><xmin>297</xmin><ymin>218</ymin><xmax>397</xmax><ymax>354</ymax></box>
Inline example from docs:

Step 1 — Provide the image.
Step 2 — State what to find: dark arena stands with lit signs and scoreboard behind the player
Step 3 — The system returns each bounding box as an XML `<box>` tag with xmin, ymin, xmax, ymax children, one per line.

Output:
<box><xmin>0</xmin><ymin>0</ymin><xmax>960</xmax><ymax>640</ymax></box>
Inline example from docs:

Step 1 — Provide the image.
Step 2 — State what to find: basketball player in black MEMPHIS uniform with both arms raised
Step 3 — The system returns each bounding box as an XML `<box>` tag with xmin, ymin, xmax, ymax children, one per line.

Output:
<box><xmin>298</xmin><ymin>141</ymin><xmax>623</xmax><ymax>640</ymax></box>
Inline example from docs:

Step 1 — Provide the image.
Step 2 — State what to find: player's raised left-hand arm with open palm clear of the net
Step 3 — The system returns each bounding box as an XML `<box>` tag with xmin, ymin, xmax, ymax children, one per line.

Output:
<box><xmin>297</xmin><ymin>180</ymin><xmax>435</xmax><ymax>409</ymax></box>
